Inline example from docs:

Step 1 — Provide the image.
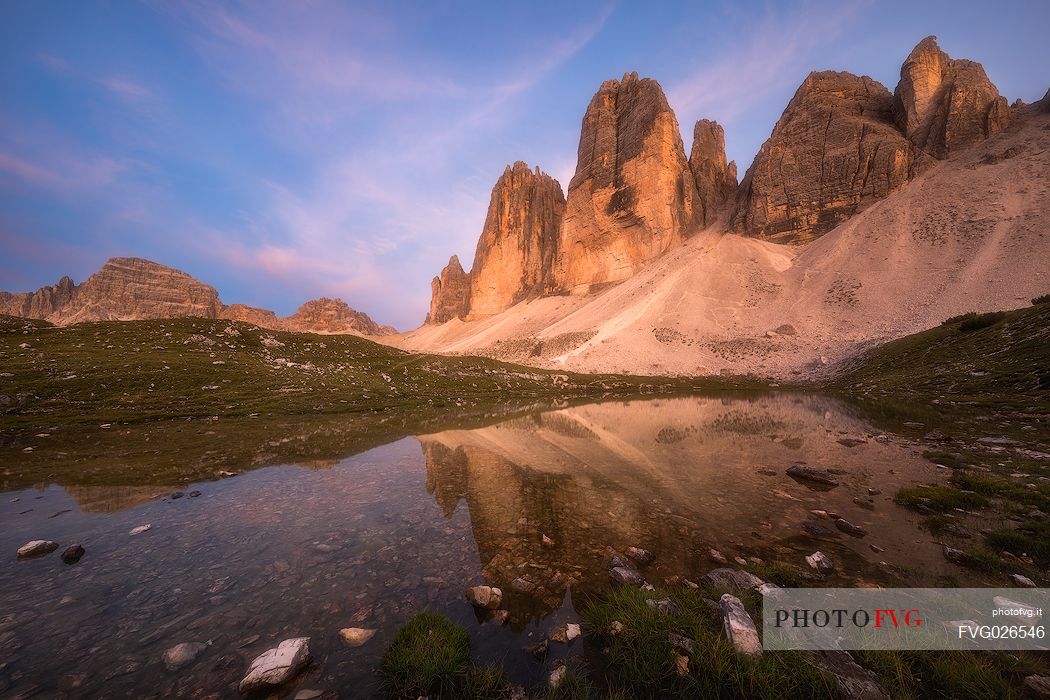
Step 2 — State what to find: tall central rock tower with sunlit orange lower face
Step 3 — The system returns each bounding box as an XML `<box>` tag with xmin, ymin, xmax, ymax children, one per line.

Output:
<box><xmin>553</xmin><ymin>73</ymin><xmax>699</xmax><ymax>293</ymax></box>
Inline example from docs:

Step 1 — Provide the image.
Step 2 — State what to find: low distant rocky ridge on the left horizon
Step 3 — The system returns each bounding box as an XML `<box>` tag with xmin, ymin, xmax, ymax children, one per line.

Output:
<box><xmin>0</xmin><ymin>257</ymin><xmax>397</xmax><ymax>335</ymax></box>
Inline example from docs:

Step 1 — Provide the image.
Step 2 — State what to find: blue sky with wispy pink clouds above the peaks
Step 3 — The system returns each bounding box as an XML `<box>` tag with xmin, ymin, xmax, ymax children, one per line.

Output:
<box><xmin>0</xmin><ymin>0</ymin><xmax>1050</xmax><ymax>328</ymax></box>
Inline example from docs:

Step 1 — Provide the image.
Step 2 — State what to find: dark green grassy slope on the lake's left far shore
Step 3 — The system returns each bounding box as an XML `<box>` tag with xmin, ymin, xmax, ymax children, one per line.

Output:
<box><xmin>0</xmin><ymin>317</ymin><xmax>756</xmax><ymax>488</ymax></box>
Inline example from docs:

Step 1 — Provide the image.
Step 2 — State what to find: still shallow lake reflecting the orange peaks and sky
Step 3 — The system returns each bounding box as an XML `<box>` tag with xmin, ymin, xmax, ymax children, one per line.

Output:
<box><xmin>0</xmin><ymin>395</ymin><xmax>958</xmax><ymax>698</ymax></box>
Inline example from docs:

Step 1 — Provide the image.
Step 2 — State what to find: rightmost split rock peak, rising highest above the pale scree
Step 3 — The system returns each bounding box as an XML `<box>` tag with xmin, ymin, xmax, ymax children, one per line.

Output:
<box><xmin>894</xmin><ymin>37</ymin><xmax>1010</xmax><ymax>158</ymax></box>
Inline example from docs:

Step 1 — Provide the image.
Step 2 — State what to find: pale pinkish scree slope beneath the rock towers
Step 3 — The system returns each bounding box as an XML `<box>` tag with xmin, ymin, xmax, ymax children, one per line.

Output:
<box><xmin>394</xmin><ymin>98</ymin><xmax>1050</xmax><ymax>380</ymax></box>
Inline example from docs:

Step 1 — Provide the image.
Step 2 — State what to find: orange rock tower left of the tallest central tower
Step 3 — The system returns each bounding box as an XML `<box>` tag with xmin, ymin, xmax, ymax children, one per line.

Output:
<box><xmin>470</xmin><ymin>161</ymin><xmax>565</xmax><ymax>318</ymax></box>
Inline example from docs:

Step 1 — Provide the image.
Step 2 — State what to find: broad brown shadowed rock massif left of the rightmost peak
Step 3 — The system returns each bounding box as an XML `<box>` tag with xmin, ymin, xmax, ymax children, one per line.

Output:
<box><xmin>733</xmin><ymin>71</ymin><xmax>920</xmax><ymax>242</ymax></box>
